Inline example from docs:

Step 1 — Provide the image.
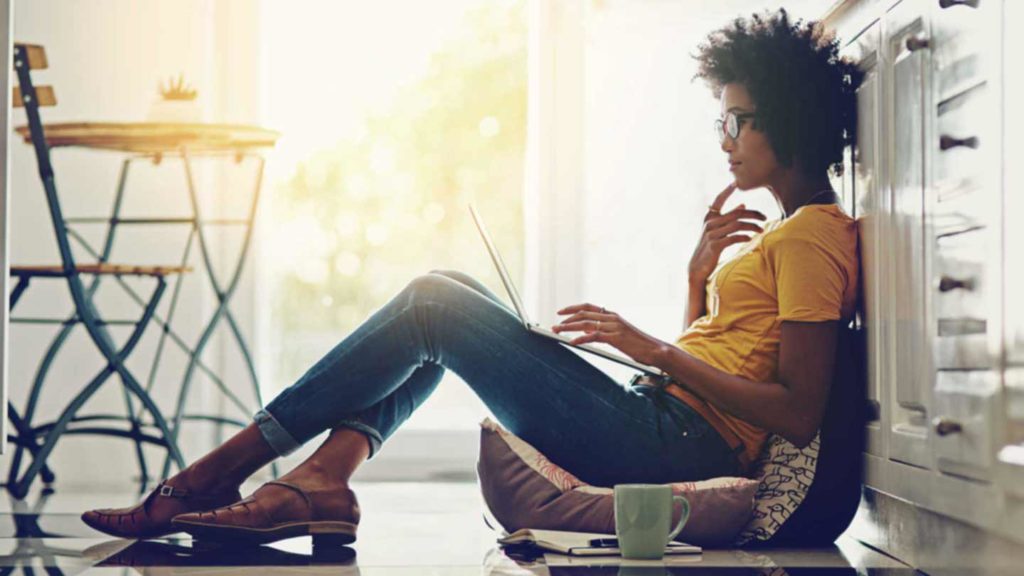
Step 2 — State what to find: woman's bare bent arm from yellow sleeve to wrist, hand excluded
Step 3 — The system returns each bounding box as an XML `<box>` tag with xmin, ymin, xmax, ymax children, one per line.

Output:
<box><xmin>654</xmin><ymin>321</ymin><xmax>839</xmax><ymax>448</ymax></box>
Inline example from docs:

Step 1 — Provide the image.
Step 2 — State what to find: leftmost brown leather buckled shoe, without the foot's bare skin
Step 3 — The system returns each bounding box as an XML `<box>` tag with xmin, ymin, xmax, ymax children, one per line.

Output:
<box><xmin>82</xmin><ymin>480</ymin><xmax>242</xmax><ymax>539</ymax></box>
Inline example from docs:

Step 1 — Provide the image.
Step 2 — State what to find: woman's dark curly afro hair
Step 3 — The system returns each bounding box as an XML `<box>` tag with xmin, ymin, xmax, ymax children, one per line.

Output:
<box><xmin>694</xmin><ymin>8</ymin><xmax>863</xmax><ymax>174</ymax></box>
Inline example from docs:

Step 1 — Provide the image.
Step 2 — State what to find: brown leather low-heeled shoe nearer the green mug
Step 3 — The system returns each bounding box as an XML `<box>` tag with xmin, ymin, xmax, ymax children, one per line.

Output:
<box><xmin>171</xmin><ymin>481</ymin><xmax>359</xmax><ymax>546</ymax></box>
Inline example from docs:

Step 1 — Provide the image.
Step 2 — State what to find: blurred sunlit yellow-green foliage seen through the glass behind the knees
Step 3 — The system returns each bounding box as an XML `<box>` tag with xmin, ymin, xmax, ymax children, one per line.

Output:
<box><xmin>267</xmin><ymin>2</ymin><xmax>526</xmax><ymax>387</ymax></box>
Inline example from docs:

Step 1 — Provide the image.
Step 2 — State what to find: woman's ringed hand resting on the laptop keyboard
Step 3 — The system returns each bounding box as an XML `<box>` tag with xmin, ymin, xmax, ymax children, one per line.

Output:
<box><xmin>551</xmin><ymin>303</ymin><xmax>669</xmax><ymax>366</ymax></box>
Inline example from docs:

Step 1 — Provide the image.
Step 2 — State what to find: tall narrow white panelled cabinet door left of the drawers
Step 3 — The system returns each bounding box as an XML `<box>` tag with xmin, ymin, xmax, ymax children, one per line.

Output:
<box><xmin>882</xmin><ymin>1</ymin><xmax>933</xmax><ymax>467</ymax></box>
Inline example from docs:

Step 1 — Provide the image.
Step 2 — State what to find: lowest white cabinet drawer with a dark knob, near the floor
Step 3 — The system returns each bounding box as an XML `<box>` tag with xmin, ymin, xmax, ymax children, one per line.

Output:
<box><xmin>932</xmin><ymin>370</ymin><xmax>1000</xmax><ymax>480</ymax></box>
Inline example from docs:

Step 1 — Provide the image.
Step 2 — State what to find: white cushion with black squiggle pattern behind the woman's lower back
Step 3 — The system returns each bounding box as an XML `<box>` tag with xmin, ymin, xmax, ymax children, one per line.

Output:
<box><xmin>736</xmin><ymin>434</ymin><xmax>821</xmax><ymax>546</ymax></box>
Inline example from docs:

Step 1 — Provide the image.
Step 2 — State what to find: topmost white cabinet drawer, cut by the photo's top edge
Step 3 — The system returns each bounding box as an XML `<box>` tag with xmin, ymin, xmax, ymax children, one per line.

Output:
<box><xmin>930</xmin><ymin>0</ymin><xmax>999</xmax><ymax>98</ymax></box>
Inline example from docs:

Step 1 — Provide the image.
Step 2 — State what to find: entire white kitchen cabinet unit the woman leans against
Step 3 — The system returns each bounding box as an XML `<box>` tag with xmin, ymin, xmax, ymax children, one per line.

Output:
<box><xmin>825</xmin><ymin>0</ymin><xmax>1024</xmax><ymax>539</ymax></box>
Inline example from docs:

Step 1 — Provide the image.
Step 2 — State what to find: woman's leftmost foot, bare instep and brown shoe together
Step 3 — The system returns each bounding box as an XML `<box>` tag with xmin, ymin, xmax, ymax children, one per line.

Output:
<box><xmin>82</xmin><ymin>466</ymin><xmax>242</xmax><ymax>539</ymax></box>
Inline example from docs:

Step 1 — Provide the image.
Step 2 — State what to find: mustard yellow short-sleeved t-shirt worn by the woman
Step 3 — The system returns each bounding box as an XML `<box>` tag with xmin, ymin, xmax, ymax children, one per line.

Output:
<box><xmin>668</xmin><ymin>204</ymin><xmax>859</xmax><ymax>462</ymax></box>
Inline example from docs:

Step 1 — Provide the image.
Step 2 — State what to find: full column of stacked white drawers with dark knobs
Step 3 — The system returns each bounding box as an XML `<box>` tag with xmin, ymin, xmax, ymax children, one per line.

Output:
<box><xmin>927</xmin><ymin>0</ymin><xmax>1005</xmax><ymax>482</ymax></box>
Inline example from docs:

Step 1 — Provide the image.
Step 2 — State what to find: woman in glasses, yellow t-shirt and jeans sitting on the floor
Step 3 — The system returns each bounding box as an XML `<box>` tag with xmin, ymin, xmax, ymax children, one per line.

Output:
<box><xmin>83</xmin><ymin>10</ymin><xmax>861</xmax><ymax>544</ymax></box>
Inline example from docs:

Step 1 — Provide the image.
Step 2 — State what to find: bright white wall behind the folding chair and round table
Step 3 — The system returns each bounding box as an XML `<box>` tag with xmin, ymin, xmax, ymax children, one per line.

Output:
<box><xmin>2</xmin><ymin>0</ymin><xmax>259</xmax><ymax>487</ymax></box>
